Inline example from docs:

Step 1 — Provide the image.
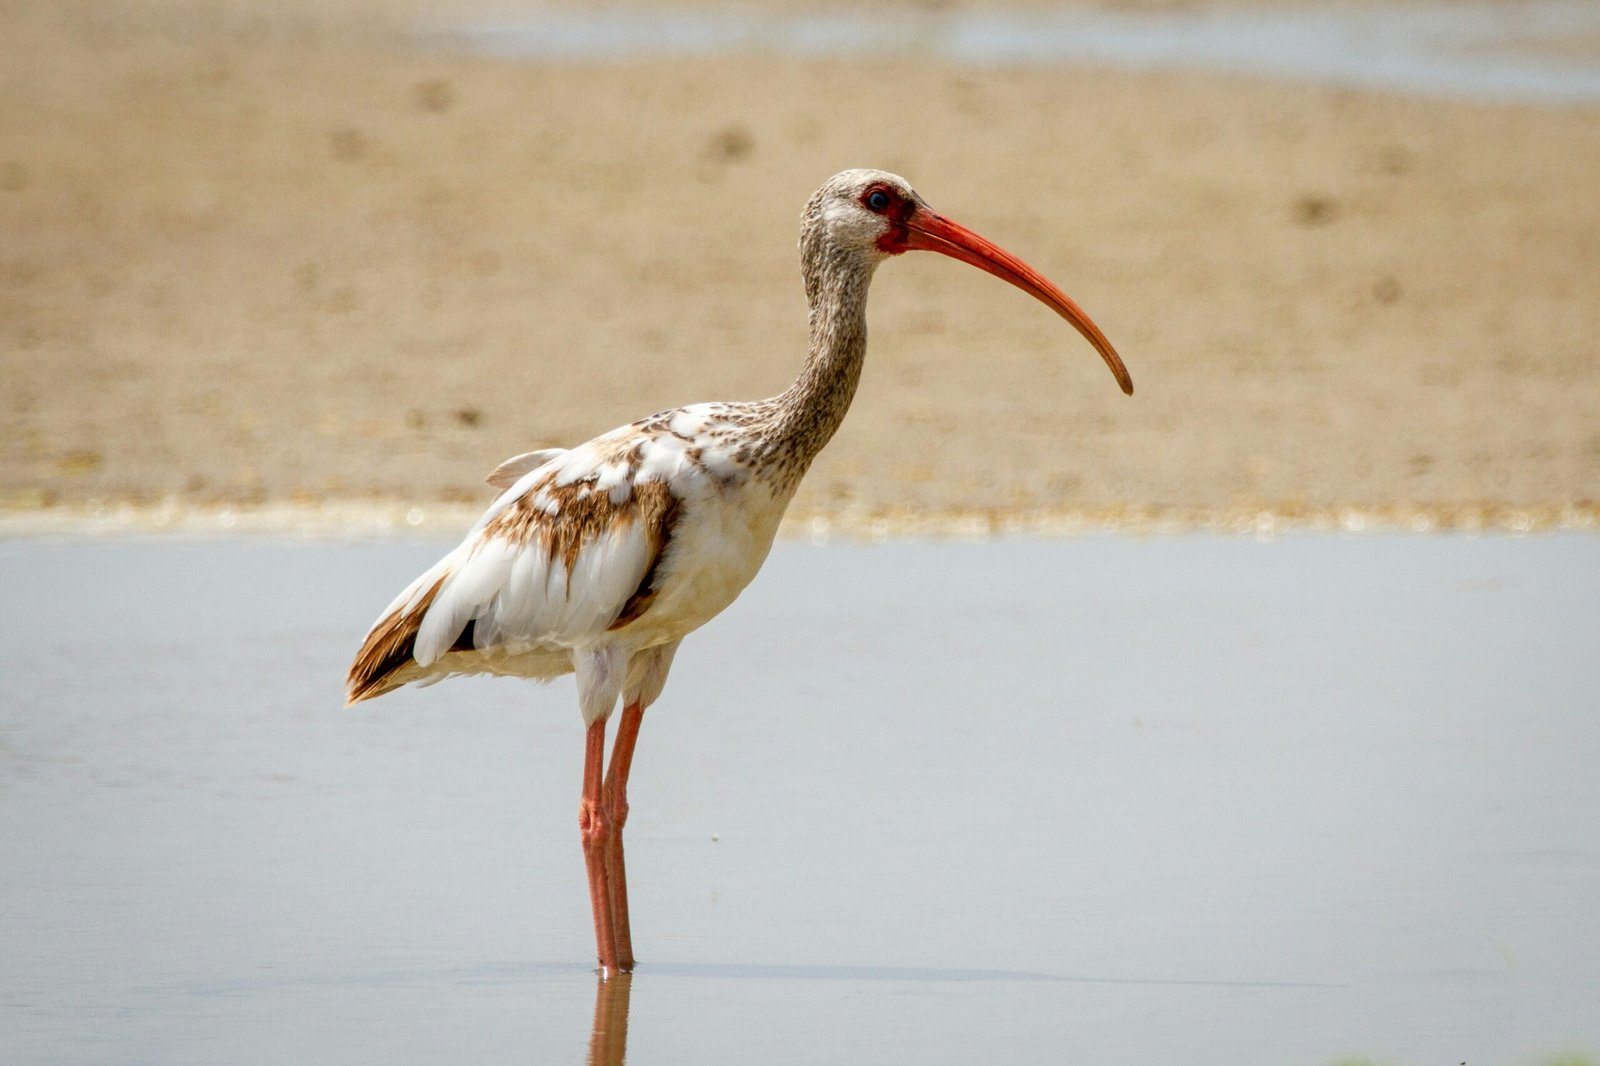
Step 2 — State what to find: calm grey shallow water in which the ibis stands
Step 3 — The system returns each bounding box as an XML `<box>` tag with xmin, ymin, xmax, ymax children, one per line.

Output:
<box><xmin>0</xmin><ymin>535</ymin><xmax>1600</xmax><ymax>1066</ymax></box>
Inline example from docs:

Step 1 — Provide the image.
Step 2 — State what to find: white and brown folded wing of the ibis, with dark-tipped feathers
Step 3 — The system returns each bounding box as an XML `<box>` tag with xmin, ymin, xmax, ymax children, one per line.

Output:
<box><xmin>349</xmin><ymin>427</ymin><xmax>682</xmax><ymax>701</ymax></box>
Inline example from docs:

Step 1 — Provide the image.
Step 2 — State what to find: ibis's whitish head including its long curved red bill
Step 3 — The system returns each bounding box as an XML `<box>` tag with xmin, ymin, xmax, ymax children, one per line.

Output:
<box><xmin>800</xmin><ymin>170</ymin><xmax>1133</xmax><ymax>395</ymax></box>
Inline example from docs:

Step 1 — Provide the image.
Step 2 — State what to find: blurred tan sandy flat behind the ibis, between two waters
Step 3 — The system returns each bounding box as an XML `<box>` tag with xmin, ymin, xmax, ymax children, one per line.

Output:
<box><xmin>0</xmin><ymin>0</ymin><xmax>1600</xmax><ymax>525</ymax></box>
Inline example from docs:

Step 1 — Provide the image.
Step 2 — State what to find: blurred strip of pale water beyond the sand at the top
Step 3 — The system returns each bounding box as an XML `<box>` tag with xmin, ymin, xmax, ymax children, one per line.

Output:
<box><xmin>422</xmin><ymin>0</ymin><xmax>1600</xmax><ymax>104</ymax></box>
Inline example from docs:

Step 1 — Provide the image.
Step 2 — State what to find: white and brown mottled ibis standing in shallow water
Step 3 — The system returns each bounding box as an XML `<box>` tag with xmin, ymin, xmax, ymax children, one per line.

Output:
<box><xmin>349</xmin><ymin>170</ymin><xmax>1133</xmax><ymax>976</ymax></box>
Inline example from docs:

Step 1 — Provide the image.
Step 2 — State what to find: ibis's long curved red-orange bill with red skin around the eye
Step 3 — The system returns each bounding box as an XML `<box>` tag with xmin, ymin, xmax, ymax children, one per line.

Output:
<box><xmin>861</xmin><ymin>184</ymin><xmax>1133</xmax><ymax>395</ymax></box>
